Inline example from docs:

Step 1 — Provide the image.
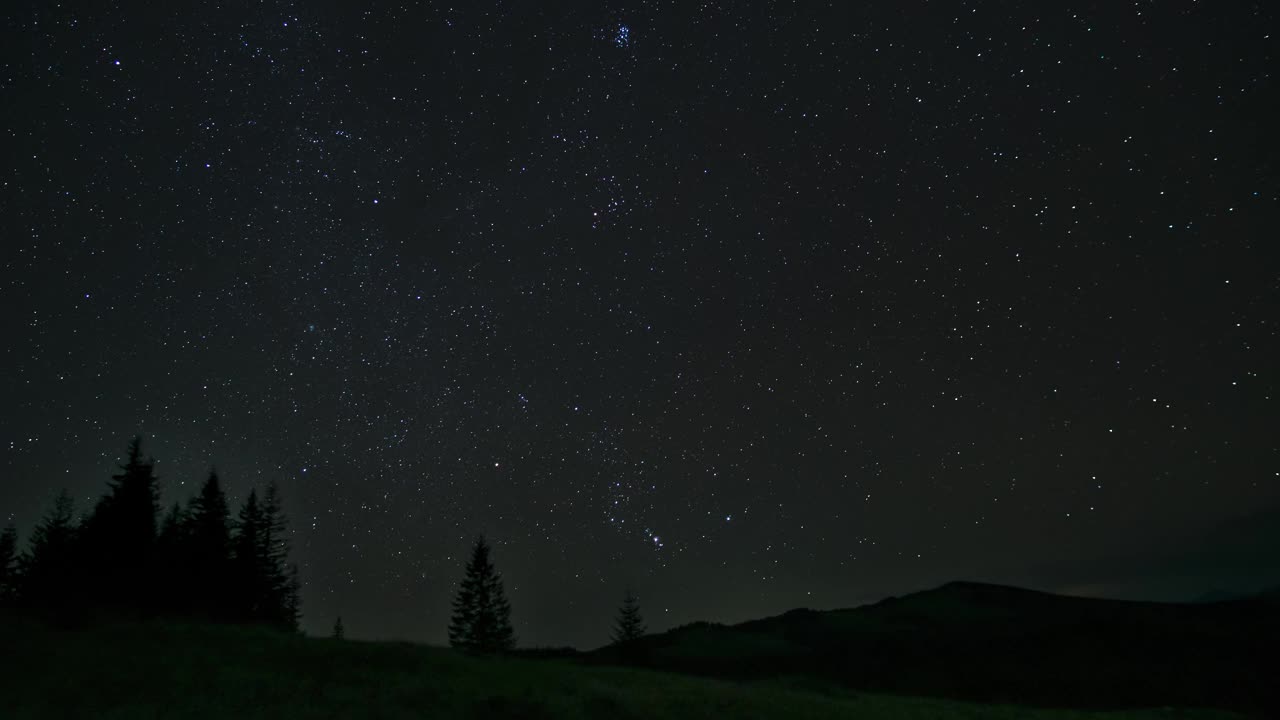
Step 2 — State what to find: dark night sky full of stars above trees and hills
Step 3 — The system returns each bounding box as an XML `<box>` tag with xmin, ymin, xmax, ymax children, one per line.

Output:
<box><xmin>0</xmin><ymin>0</ymin><xmax>1280</xmax><ymax>647</ymax></box>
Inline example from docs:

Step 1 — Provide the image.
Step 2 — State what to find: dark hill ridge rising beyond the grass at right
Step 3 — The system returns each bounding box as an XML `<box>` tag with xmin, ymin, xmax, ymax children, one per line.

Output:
<box><xmin>588</xmin><ymin>583</ymin><xmax>1280</xmax><ymax>716</ymax></box>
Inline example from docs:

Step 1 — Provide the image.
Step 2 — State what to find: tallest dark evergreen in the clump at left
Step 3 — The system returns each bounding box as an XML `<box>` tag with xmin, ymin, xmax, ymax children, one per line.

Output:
<box><xmin>84</xmin><ymin>437</ymin><xmax>160</xmax><ymax>610</ymax></box>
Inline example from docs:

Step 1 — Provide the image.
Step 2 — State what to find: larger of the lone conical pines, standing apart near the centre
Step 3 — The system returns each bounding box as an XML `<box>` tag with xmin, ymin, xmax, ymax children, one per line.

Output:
<box><xmin>449</xmin><ymin>536</ymin><xmax>516</xmax><ymax>652</ymax></box>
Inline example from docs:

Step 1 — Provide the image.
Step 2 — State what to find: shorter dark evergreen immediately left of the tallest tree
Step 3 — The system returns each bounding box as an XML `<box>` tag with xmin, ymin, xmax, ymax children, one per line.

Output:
<box><xmin>18</xmin><ymin>489</ymin><xmax>81</xmax><ymax>614</ymax></box>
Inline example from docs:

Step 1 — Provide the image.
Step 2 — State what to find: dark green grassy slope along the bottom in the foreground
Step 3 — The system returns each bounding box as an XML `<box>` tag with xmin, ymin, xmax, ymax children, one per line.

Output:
<box><xmin>0</xmin><ymin>619</ymin><xmax>1236</xmax><ymax>720</ymax></box>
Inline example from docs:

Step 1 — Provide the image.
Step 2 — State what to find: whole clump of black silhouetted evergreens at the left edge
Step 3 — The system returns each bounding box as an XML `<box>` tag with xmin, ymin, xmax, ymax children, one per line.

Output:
<box><xmin>0</xmin><ymin>430</ymin><xmax>300</xmax><ymax>630</ymax></box>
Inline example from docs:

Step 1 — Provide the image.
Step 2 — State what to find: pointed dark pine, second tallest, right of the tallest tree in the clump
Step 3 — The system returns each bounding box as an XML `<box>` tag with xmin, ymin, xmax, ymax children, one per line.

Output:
<box><xmin>186</xmin><ymin>470</ymin><xmax>232</xmax><ymax>618</ymax></box>
